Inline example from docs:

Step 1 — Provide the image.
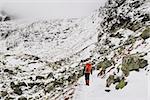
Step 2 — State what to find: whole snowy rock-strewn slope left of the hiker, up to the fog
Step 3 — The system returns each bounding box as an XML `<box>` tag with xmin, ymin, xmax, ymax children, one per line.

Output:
<box><xmin>0</xmin><ymin>9</ymin><xmax>100</xmax><ymax>100</ymax></box>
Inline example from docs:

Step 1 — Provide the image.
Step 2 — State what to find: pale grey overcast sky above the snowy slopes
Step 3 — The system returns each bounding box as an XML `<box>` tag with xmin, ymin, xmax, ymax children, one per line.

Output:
<box><xmin>0</xmin><ymin>0</ymin><xmax>106</xmax><ymax>18</ymax></box>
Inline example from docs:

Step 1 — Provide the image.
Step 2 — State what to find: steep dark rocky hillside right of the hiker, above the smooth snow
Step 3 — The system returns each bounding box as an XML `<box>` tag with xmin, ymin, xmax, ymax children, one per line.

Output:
<box><xmin>94</xmin><ymin>0</ymin><xmax>150</xmax><ymax>91</ymax></box>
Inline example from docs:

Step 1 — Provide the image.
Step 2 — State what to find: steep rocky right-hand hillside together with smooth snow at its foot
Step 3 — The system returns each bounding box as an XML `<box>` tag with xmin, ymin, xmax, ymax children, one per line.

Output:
<box><xmin>74</xmin><ymin>0</ymin><xmax>150</xmax><ymax>100</ymax></box>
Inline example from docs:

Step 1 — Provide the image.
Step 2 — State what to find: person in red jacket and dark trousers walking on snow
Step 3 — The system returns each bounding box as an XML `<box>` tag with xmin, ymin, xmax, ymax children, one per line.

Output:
<box><xmin>83</xmin><ymin>63</ymin><xmax>92</xmax><ymax>85</ymax></box>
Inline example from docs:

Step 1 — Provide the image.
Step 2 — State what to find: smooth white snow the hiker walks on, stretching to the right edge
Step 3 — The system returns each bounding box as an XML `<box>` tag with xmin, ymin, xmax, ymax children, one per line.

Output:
<box><xmin>73</xmin><ymin>71</ymin><xmax>148</xmax><ymax>100</ymax></box>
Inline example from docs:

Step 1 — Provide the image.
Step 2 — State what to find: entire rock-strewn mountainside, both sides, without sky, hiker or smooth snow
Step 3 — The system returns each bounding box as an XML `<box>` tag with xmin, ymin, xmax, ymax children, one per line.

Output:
<box><xmin>0</xmin><ymin>0</ymin><xmax>150</xmax><ymax>100</ymax></box>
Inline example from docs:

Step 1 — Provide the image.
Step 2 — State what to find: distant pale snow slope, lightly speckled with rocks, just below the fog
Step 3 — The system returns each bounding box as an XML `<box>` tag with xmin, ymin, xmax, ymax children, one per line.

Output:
<box><xmin>0</xmin><ymin>15</ymin><xmax>97</xmax><ymax>61</ymax></box>
